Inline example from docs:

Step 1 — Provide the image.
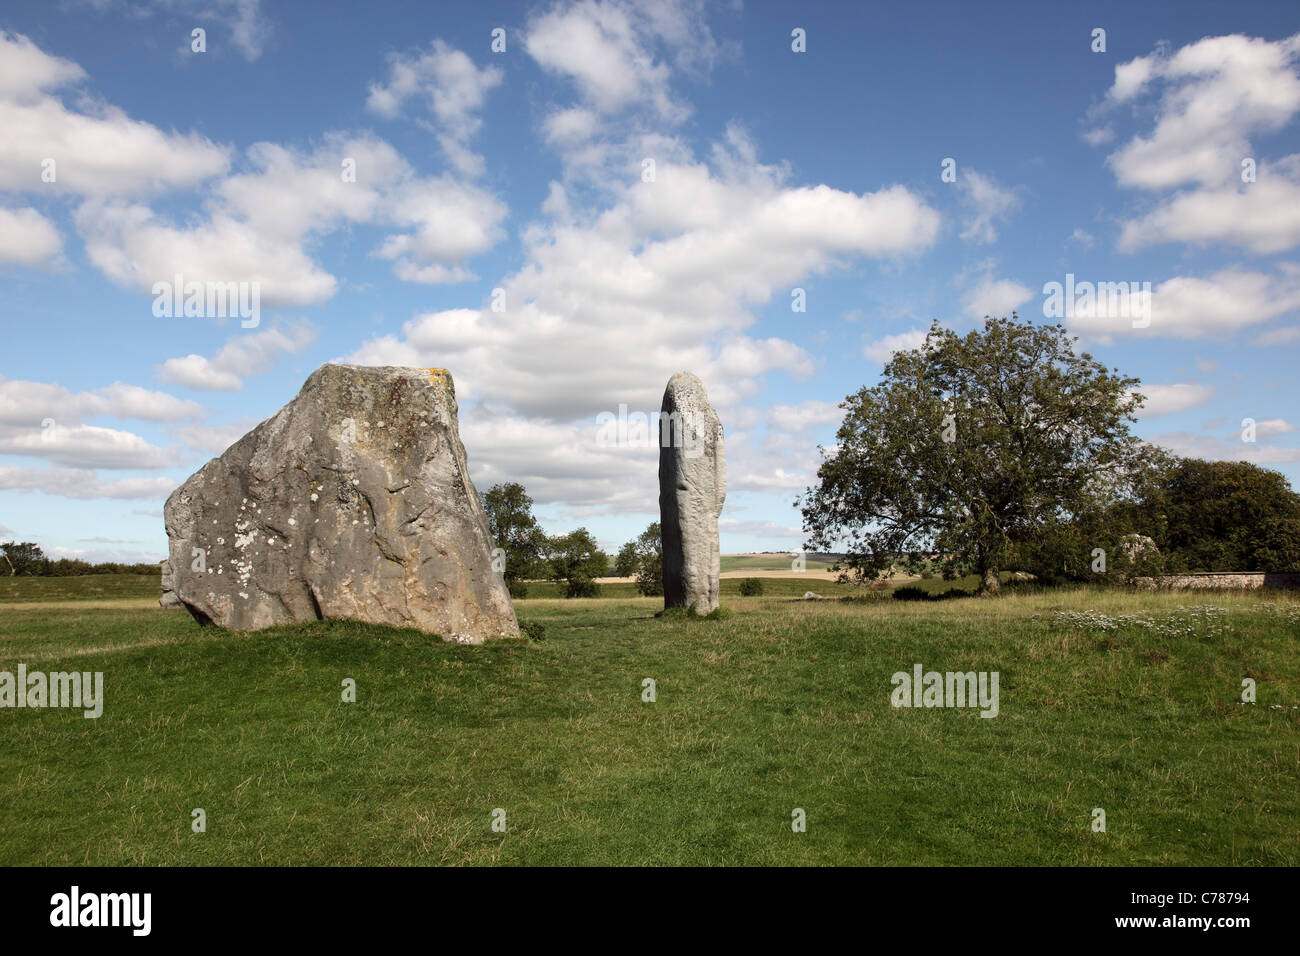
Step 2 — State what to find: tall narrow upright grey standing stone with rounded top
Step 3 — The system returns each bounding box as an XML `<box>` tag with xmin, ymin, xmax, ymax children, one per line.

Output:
<box><xmin>659</xmin><ymin>372</ymin><xmax>727</xmax><ymax>614</ymax></box>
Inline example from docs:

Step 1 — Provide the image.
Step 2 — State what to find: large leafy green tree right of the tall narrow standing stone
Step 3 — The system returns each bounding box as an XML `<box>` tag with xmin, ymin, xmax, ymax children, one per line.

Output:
<box><xmin>801</xmin><ymin>312</ymin><xmax>1143</xmax><ymax>593</ymax></box>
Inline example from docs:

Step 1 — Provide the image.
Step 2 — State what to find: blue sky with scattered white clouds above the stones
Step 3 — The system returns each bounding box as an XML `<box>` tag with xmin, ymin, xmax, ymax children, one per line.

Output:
<box><xmin>0</xmin><ymin>0</ymin><xmax>1300</xmax><ymax>561</ymax></box>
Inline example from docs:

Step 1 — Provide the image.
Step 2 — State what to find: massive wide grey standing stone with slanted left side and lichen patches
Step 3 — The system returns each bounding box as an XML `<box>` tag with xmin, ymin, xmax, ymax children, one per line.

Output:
<box><xmin>164</xmin><ymin>365</ymin><xmax>519</xmax><ymax>644</ymax></box>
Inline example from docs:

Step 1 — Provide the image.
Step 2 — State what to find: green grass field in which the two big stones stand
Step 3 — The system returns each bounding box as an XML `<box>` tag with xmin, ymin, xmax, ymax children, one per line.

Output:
<box><xmin>0</xmin><ymin>578</ymin><xmax>1300</xmax><ymax>865</ymax></box>
